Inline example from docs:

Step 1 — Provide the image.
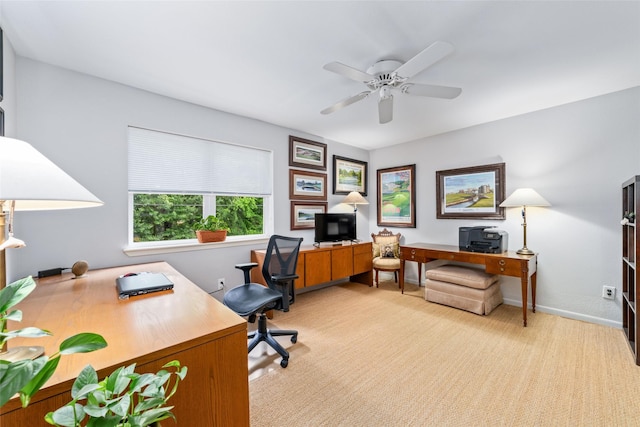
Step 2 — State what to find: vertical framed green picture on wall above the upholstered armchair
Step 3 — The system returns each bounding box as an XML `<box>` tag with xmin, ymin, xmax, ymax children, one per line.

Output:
<box><xmin>377</xmin><ymin>164</ymin><xmax>416</xmax><ymax>228</ymax></box>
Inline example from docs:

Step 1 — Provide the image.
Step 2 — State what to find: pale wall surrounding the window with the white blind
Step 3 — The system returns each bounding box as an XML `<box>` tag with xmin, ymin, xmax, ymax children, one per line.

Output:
<box><xmin>7</xmin><ymin>57</ymin><xmax>368</xmax><ymax>298</ymax></box>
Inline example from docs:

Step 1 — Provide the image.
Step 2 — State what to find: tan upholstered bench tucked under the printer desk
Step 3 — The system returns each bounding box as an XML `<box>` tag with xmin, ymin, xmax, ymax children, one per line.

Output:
<box><xmin>424</xmin><ymin>265</ymin><xmax>502</xmax><ymax>314</ymax></box>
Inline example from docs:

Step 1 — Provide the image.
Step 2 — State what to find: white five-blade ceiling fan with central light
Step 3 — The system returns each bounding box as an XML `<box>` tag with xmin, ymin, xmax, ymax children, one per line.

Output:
<box><xmin>320</xmin><ymin>41</ymin><xmax>462</xmax><ymax>124</ymax></box>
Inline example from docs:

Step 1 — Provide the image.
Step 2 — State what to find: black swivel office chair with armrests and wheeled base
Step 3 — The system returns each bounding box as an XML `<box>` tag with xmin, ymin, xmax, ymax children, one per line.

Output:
<box><xmin>224</xmin><ymin>235</ymin><xmax>302</xmax><ymax>368</ymax></box>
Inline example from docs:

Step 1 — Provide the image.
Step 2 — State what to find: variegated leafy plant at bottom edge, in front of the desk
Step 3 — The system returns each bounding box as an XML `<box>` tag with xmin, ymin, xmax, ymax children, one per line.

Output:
<box><xmin>45</xmin><ymin>360</ymin><xmax>187</xmax><ymax>427</ymax></box>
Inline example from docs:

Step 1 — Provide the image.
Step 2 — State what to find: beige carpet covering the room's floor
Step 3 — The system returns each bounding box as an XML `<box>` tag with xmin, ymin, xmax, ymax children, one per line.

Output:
<box><xmin>249</xmin><ymin>282</ymin><xmax>640</xmax><ymax>427</ymax></box>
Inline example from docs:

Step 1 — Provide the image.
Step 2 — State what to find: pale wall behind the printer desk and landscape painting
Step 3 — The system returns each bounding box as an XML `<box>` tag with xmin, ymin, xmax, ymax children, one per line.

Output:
<box><xmin>370</xmin><ymin>88</ymin><xmax>640</xmax><ymax>327</ymax></box>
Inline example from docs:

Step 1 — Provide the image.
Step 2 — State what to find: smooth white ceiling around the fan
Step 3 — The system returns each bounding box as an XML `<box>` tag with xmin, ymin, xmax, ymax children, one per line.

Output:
<box><xmin>0</xmin><ymin>0</ymin><xmax>640</xmax><ymax>149</ymax></box>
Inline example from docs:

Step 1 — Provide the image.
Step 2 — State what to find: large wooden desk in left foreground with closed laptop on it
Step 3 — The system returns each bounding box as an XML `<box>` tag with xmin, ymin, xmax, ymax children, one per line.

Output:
<box><xmin>0</xmin><ymin>262</ymin><xmax>249</xmax><ymax>426</ymax></box>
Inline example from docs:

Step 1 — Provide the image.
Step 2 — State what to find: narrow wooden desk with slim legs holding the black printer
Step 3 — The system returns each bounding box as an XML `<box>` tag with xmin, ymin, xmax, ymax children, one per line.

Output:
<box><xmin>399</xmin><ymin>243</ymin><xmax>538</xmax><ymax>326</ymax></box>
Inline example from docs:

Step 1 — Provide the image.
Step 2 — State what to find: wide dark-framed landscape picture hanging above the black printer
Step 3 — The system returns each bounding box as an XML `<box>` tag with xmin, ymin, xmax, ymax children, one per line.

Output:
<box><xmin>436</xmin><ymin>163</ymin><xmax>505</xmax><ymax>219</ymax></box>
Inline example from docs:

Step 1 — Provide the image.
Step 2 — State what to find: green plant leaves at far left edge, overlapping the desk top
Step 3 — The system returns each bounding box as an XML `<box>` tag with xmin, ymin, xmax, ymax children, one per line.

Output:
<box><xmin>0</xmin><ymin>276</ymin><xmax>107</xmax><ymax>407</ymax></box>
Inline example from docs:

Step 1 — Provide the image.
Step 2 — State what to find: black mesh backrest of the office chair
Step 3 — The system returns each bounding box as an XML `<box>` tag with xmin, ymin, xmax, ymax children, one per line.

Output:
<box><xmin>262</xmin><ymin>235</ymin><xmax>302</xmax><ymax>289</ymax></box>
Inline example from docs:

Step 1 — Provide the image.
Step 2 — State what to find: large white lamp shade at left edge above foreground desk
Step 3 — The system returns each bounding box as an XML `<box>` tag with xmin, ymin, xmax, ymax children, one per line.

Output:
<box><xmin>0</xmin><ymin>137</ymin><xmax>103</xmax><ymax>211</ymax></box>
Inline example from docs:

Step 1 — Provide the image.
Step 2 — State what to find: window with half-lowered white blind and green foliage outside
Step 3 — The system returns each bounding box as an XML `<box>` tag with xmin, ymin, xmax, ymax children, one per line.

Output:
<box><xmin>129</xmin><ymin>127</ymin><xmax>273</xmax><ymax>245</ymax></box>
